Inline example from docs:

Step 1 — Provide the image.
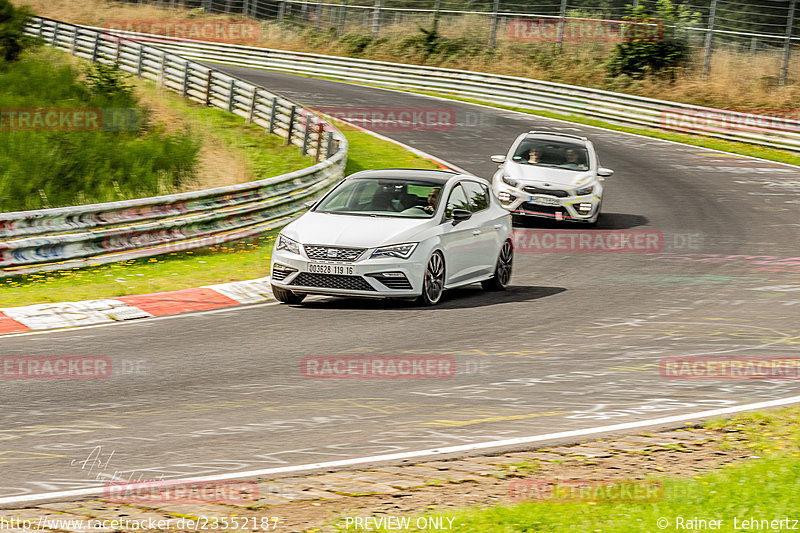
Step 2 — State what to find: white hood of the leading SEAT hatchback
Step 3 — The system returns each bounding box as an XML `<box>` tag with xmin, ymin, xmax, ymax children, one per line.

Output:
<box><xmin>281</xmin><ymin>211</ymin><xmax>432</xmax><ymax>248</ymax></box>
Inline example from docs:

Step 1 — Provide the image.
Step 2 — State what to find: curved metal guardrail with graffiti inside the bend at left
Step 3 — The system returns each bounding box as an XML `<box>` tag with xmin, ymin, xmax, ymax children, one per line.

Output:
<box><xmin>0</xmin><ymin>17</ymin><xmax>348</xmax><ymax>275</ymax></box>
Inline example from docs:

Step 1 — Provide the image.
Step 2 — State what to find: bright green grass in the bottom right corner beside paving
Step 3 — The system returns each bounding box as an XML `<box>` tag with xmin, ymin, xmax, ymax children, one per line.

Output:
<box><xmin>370</xmin><ymin>407</ymin><xmax>800</xmax><ymax>533</ymax></box>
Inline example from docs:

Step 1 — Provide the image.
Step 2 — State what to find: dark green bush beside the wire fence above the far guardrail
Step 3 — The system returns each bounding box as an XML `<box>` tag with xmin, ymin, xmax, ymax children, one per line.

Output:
<box><xmin>607</xmin><ymin>0</ymin><xmax>698</xmax><ymax>80</ymax></box>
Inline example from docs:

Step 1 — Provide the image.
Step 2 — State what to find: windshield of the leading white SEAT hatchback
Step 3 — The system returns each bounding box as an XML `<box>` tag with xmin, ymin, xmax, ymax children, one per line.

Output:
<box><xmin>314</xmin><ymin>179</ymin><xmax>442</xmax><ymax>218</ymax></box>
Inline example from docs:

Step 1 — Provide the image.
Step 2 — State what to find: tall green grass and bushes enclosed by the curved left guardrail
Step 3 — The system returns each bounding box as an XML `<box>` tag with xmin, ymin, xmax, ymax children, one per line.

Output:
<box><xmin>0</xmin><ymin>49</ymin><xmax>199</xmax><ymax>212</ymax></box>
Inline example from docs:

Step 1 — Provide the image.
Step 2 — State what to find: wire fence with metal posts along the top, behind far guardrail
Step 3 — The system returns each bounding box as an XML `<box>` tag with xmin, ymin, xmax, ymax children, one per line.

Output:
<box><xmin>112</xmin><ymin>0</ymin><xmax>800</xmax><ymax>84</ymax></box>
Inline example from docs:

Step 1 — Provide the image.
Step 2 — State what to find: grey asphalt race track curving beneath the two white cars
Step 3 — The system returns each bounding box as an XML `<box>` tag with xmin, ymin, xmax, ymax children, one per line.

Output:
<box><xmin>0</xmin><ymin>67</ymin><xmax>800</xmax><ymax>504</ymax></box>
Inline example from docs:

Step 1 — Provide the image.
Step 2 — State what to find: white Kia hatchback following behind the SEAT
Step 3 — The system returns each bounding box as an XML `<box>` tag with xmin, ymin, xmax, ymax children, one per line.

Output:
<box><xmin>492</xmin><ymin>131</ymin><xmax>614</xmax><ymax>224</ymax></box>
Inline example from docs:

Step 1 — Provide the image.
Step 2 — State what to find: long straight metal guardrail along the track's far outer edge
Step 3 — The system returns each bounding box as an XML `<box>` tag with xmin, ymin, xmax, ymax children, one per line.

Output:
<box><xmin>98</xmin><ymin>28</ymin><xmax>800</xmax><ymax>152</ymax></box>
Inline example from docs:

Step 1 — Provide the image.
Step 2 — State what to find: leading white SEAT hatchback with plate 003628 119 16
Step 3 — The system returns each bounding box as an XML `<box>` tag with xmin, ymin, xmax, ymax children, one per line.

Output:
<box><xmin>271</xmin><ymin>169</ymin><xmax>514</xmax><ymax>305</ymax></box>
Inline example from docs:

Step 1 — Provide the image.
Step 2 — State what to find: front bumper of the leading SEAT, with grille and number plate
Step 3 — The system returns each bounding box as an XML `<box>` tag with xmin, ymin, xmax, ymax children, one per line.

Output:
<box><xmin>270</xmin><ymin>250</ymin><xmax>427</xmax><ymax>298</ymax></box>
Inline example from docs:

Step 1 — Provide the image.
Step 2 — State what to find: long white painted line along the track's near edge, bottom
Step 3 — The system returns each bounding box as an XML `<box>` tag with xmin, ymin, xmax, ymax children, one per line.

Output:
<box><xmin>0</xmin><ymin>396</ymin><xmax>800</xmax><ymax>506</ymax></box>
